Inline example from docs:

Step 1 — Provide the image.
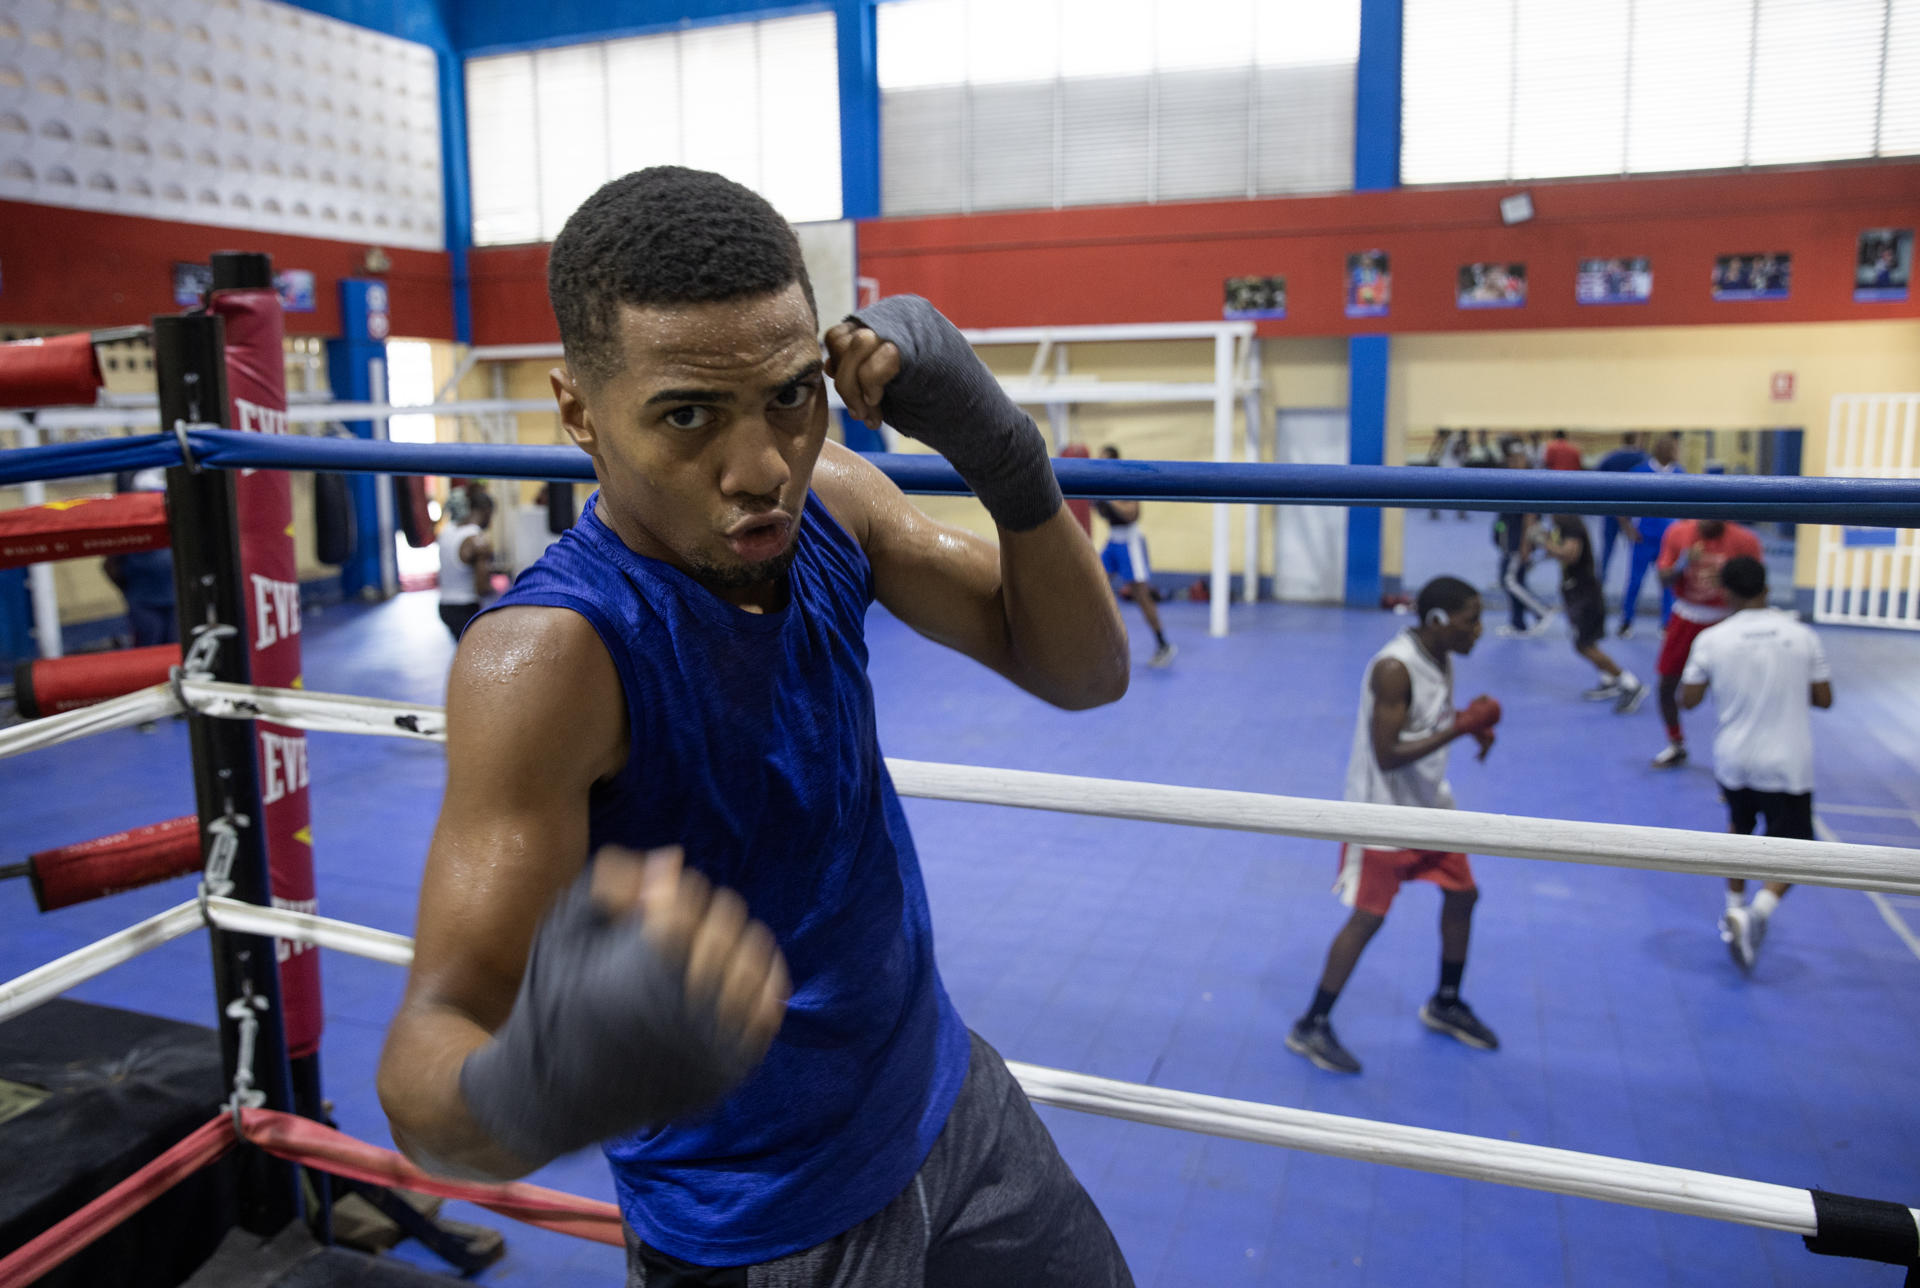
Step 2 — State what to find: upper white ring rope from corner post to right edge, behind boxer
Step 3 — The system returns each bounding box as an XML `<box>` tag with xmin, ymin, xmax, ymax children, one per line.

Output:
<box><xmin>153</xmin><ymin>680</ymin><xmax>1920</xmax><ymax>894</ymax></box>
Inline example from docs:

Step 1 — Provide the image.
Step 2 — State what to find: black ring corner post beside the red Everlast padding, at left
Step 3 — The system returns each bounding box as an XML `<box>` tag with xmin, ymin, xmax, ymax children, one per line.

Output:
<box><xmin>154</xmin><ymin>313</ymin><xmax>300</xmax><ymax>1234</ymax></box>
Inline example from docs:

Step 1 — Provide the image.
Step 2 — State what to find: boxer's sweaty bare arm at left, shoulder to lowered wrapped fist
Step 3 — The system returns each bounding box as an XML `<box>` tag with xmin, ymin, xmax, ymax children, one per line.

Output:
<box><xmin>380</xmin><ymin>607</ymin><xmax>628</xmax><ymax>1177</ymax></box>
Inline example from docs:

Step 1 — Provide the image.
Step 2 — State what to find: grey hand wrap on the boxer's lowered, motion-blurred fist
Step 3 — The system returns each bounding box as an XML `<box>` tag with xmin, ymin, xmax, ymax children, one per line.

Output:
<box><xmin>461</xmin><ymin>873</ymin><xmax>756</xmax><ymax>1163</ymax></box>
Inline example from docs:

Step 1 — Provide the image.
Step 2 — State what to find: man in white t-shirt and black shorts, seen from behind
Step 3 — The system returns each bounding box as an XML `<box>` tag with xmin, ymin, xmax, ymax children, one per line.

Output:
<box><xmin>1680</xmin><ymin>555</ymin><xmax>1834</xmax><ymax>969</ymax></box>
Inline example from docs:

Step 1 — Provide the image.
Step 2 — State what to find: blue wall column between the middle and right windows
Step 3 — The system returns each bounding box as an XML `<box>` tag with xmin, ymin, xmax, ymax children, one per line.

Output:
<box><xmin>1346</xmin><ymin>0</ymin><xmax>1404</xmax><ymax>605</ymax></box>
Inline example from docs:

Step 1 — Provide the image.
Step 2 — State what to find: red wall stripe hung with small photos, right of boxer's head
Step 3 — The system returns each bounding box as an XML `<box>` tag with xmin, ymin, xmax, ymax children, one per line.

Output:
<box><xmin>860</xmin><ymin>163</ymin><xmax>1920</xmax><ymax>336</ymax></box>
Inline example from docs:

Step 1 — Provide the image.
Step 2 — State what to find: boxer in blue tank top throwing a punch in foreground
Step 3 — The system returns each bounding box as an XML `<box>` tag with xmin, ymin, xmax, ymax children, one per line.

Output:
<box><xmin>380</xmin><ymin>167</ymin><xmax>1131</xmax><ymax>1288</ymax></box>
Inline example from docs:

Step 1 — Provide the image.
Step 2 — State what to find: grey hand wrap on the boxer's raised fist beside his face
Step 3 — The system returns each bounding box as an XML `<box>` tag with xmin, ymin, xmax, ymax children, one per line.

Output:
<box><xmin>847</xmin><ymin>296</ymin><xmax>1060</xmax><ymax>532</ymax></box>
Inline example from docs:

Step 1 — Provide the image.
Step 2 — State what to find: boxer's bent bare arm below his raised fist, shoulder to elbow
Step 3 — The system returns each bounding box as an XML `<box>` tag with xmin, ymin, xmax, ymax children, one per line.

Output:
<box><xmin>814</xmin><ymin>441</ymin><xmax>1129</xmax><ymax>710</ymax></box>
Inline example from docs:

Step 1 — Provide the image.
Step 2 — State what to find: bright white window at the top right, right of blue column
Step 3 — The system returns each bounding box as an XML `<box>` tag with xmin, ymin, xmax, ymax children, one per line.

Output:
<box><xmin>1400</xmin><ymin>0</ymin><xmax>1920</xmax><ymax>184</ymax></box>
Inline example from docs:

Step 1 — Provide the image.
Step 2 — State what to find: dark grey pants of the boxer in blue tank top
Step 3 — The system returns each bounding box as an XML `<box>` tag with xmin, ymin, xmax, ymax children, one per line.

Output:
<box><xmin>626</xmin><ymin>1033</ymin><xmax>1133</xmax><ymax>1288</ymax></box>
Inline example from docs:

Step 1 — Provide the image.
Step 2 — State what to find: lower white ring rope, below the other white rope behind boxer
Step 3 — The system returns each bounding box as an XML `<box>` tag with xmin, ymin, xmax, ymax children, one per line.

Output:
<box><xmin>0</xmin><ymin>896</ymin><xmax>1920</xmax><ymax>1244</ymax></box>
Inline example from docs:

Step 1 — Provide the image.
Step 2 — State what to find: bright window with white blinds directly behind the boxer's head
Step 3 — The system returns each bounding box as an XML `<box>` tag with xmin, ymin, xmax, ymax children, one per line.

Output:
<box><xmin>467</xmin><ymin>13</ymin><xmax>841</xmax><ymax>246</ymax></box>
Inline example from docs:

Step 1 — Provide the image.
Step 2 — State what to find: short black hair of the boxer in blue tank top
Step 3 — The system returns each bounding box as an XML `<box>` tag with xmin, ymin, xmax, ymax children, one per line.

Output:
<box><xmin>547</xmin><ymin>165</ymin><xmax>820</xmax><ymax>382</ymax></box>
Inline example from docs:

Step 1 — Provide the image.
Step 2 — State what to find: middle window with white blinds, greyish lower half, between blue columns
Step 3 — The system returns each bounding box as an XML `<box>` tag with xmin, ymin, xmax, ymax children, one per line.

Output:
<box><xmin>877</xmin><ymin>0</ymin><xmax>1359</xmax><ymax>215</ymax></box>
